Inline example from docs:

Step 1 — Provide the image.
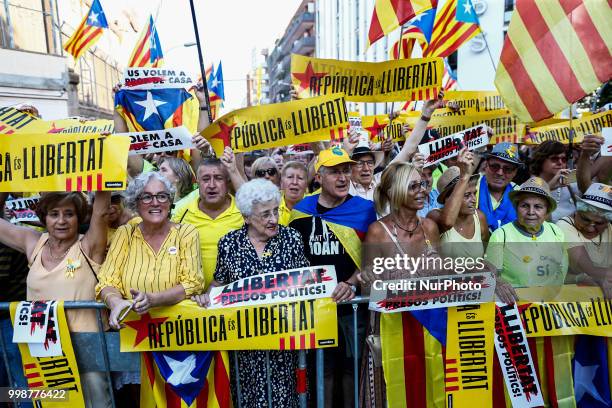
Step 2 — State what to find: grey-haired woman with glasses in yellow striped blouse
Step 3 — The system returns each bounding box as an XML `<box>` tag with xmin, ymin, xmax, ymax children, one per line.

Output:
<box><xmin>96</xmin><ymin>172</ymin><xmax>204</xmax><ymax>329</ymax></box>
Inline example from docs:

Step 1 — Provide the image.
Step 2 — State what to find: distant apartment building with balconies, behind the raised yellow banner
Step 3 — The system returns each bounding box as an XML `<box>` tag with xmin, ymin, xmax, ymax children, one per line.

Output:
<box><xmin>267</xmin><ymin>0</ymin><xmax>316</xmax><ymax>103</ymax></box>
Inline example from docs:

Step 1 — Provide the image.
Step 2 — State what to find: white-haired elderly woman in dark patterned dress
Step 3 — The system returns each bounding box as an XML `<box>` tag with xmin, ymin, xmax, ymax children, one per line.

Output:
<box><xmin>194</xmin><ymin>179</ymin><xmax>309</xmax><ymax>407</ymax></box>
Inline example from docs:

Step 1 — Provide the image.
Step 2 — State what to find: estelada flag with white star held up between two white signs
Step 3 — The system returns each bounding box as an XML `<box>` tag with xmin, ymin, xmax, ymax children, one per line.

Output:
<box><xmin>115</xmin><ymin>88</ymin><xmax>200</xmax><ymax>134</ymax></box>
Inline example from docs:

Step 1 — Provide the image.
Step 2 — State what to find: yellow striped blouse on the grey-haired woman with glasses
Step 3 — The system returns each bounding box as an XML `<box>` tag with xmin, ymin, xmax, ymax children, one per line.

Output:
<box><xmin>96</xmin><ymin>224</ymin><xmax>204</xmax><ymax>299</ymax></box>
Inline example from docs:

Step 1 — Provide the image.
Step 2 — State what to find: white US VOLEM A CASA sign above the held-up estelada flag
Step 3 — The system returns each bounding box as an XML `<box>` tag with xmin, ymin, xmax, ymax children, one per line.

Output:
<box><xmin>123</xmin><ymin>68</ymin><xmax>194</xmax><ymax>89</ymax></box>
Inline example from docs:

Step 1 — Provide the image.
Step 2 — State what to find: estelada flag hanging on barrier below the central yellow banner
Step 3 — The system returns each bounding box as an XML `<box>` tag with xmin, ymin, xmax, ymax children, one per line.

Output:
<box><xmin>140</xmin><ymin>351</ymin><xmax>232</xmax><ymax>408</ymax></box>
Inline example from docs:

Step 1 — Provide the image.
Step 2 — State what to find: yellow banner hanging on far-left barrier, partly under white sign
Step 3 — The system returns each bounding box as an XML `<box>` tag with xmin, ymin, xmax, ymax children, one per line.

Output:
<box><xmin>10</xmin><ymin>301</ymin><xmax>85</xmax><ymax>408</ymax></box>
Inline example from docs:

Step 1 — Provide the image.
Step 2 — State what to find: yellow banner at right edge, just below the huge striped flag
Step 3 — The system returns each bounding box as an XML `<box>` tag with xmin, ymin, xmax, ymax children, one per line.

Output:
<box><xmin>525</xmin><ymin>111</ymin><xmax>612</xmax><ymax>144</ymax></box>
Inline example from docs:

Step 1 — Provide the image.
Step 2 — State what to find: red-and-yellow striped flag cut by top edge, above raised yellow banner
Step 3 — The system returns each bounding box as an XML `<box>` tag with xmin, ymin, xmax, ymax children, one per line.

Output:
<box><xmin>366</xmin><ymin>0</ymin><xmax>438</xmax><ymax>48</ymax></box>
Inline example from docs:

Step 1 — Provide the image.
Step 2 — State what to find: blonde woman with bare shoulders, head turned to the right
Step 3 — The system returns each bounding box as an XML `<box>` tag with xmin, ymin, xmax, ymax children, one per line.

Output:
<box><xmin>360</xmin><ymin>162</ymin><xmax>439</xmax><ymax>408</ymax></box>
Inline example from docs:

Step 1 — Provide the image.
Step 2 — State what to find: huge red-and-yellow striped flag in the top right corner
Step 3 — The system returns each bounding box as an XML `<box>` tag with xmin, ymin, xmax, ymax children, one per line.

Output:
<box><xmin>495</xmin><ymin>0</ymin><xmax>612</xmax><ymax>122</ymax></box>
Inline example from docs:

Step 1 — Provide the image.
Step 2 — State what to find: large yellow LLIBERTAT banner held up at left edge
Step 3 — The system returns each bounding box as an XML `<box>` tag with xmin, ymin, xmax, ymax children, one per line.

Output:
<box><xmin>0</xmin><ymin>134</ymin><xmax>130</xmax><ymax>192</ymax></box>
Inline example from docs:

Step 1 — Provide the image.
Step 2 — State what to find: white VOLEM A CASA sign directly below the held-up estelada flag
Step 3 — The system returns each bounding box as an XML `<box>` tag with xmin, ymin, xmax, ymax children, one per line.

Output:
<box><xmin>116</xmin><ymin>126</ymin><xmax>193</xmax><ymax>156</ymax></box>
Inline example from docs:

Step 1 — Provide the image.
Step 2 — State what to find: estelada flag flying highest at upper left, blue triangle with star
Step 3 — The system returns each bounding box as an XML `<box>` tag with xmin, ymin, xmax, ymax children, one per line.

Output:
<box><xmin>64</xmin><ymin>0</ymin><xmax>108</xmax><ymax>61</ymax></box>
